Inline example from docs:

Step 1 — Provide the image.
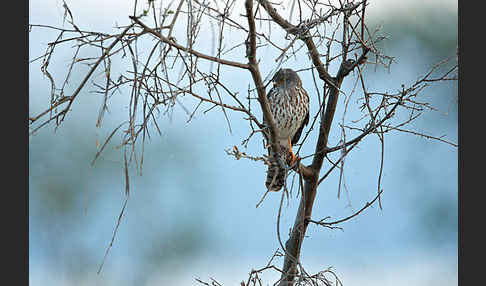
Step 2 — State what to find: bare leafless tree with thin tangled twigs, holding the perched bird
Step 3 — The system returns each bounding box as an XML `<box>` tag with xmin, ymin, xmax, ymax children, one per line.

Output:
<box><xmin>29</xmin><ymin>0</ymin><xmax>457</xmax><ymax>285</ymax></box>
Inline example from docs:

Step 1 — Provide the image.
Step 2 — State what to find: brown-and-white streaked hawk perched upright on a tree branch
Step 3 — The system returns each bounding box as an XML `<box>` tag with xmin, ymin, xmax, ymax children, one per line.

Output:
<box><xmin>263</xmin><ymin>68</ymin><xmax>309</xmax><ymax>192</ymax></box>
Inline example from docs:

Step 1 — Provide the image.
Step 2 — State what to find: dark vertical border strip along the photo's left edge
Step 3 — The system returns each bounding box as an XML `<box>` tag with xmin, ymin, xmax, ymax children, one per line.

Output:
<box><xmin>8</xmin><ymin>1</ymin><xmax>29</xmax><ymax>285</ymax></box>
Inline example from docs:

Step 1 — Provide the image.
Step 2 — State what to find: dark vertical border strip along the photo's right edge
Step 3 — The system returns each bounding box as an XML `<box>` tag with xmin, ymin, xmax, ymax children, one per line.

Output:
<box><xmin>460</xmin><ymin>1</ymin><xmax>478</xmax><ymax>285</ymax></box>
